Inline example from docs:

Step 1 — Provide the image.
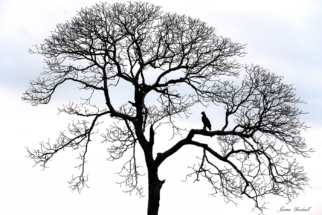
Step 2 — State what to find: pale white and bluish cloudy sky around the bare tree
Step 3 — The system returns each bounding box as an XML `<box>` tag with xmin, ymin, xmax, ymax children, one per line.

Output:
<box><xmin>0</xmin><ymin>0</ymin><xmax>322</xmax><ymax>215</ymax></box>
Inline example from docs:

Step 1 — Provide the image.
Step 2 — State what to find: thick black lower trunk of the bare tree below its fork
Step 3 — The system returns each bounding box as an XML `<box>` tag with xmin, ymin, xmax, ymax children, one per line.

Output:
<box><xmin>148</xmin><ymin>170</ymin><xmax>164</xmax><ymax>215</ymax></box>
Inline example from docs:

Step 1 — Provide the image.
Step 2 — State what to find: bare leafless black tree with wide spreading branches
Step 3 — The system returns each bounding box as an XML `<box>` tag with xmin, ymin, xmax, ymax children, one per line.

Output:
<box><xmin>22</xmin><ymin>2</ymin><xmax>313</xmax><ymax>215</ymax></box>
